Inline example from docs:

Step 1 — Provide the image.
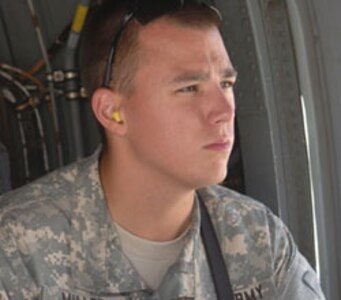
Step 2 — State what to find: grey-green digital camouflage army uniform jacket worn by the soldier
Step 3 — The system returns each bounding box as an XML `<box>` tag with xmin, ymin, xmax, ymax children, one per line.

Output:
<box><xmin>0</xmin><ymin>151</ymin><xmax>324</xmax><ymax>300</ymax></box>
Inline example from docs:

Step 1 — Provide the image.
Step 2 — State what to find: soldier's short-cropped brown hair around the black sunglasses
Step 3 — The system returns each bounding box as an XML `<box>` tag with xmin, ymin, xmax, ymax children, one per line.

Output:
<box><xmin>80</xmin><ymin>0</ymin><xmax>220</xmax><ymax>96</ymax></box>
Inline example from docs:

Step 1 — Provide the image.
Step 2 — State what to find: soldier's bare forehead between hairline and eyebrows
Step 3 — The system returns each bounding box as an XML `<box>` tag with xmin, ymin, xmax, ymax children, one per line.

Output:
<box><xmin>139</xmin><ymin>18</ymin><xmax>231</xmax><ymax>68</ymax></box>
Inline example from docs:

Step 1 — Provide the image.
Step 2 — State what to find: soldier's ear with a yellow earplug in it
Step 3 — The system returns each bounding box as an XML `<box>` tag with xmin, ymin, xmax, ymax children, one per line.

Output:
<box><xmin>91</xmin><ymin>88</ymin><xmax>127</xmax><ymax>136</ymax></box>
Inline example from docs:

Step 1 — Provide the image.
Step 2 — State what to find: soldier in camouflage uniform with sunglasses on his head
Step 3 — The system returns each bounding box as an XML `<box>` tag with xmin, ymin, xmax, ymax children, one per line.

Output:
<box><xmin>0</xmin><ymin>0</ymin><xmax>324</xmax><ymax>300</ymax></box>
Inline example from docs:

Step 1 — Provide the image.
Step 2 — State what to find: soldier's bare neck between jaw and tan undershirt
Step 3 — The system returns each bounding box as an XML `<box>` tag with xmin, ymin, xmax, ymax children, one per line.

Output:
<box><xmin>100</xmin><ymin>148</ymin><xmax>195</xmax><ymax>241</ymax></box>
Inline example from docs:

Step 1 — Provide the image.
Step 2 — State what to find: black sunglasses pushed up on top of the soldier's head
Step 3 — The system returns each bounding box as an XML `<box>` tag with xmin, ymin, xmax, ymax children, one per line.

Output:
<box><xmin>102</xmin><ymin>0</ymin><xmax>222</xmax><ymax>87</ymax></box>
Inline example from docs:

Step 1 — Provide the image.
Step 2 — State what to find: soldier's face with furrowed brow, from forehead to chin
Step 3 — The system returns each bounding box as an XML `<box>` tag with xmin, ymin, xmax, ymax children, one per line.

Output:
<box><xmin>122</xmin><ymin>18</ymin><xmax>235</xmax><ymax>188</ymax></box>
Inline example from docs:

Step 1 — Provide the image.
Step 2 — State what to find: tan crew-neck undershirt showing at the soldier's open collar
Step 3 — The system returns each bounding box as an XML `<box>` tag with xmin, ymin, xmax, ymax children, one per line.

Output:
<box><xmin>116</xmin><ymin>224</ymin><xmax>188</xmax><ymax>290</ymax></box>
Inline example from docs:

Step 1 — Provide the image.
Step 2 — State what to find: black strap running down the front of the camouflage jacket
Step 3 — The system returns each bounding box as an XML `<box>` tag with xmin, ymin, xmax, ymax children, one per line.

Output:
<box><xmin>198</xmin><ymin>196</ymin><xmax>234</xmax><ymax>300</ymax></box>
